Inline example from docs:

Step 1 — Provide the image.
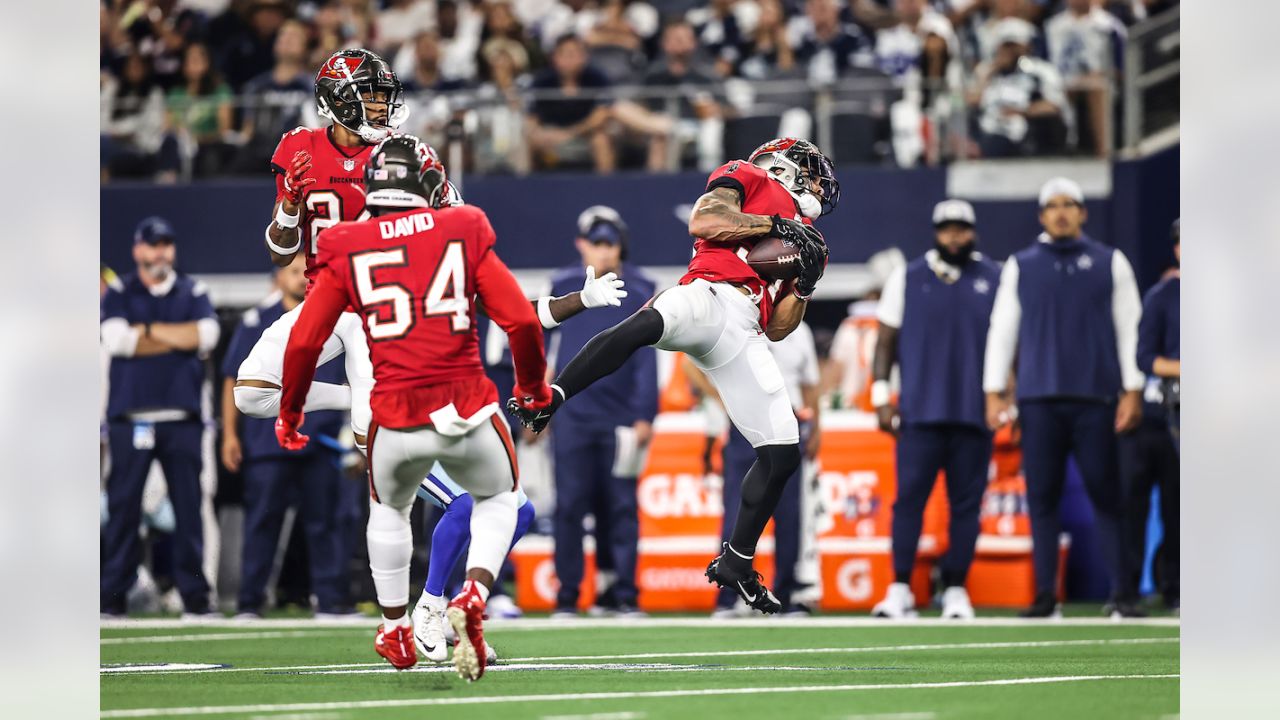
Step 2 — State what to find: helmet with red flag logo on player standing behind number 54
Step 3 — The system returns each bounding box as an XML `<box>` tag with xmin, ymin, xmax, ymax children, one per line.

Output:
<box><xmin>315</xmin><ymin>49</ymin><xmax>408</xmax><ymax>145</ymax></box>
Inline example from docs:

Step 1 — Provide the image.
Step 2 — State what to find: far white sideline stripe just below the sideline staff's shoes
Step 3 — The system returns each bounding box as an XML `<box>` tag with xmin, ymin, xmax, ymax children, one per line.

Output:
<box><xmin>99</xmin><ymin>615</ymin><xmax>1181</xmax><ymax>632</ymax></box>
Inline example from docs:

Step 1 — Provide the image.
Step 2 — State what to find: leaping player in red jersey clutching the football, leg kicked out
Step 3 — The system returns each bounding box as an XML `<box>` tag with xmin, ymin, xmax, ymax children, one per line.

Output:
<box><xmin>509</xmin><ymin>137</ymin><xmax>840</xmax><ymax>614</ymax></box>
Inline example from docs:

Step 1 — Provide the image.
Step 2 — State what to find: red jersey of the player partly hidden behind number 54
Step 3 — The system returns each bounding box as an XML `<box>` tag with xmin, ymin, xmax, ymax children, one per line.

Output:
<box><xmin>271</xmin><ymin>127</ymin><xmax>372</xmax><ymax>292</ymax></box>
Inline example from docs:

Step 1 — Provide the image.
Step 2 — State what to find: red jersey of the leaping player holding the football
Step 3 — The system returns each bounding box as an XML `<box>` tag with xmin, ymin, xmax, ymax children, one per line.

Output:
<box><xmin>680</xmin><ymin>160</ymin><xmax>812</xmax><ymax>327</ymax></box>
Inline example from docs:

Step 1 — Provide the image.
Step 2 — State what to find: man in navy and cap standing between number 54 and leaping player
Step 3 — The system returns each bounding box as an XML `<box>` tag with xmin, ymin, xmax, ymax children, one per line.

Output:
<box><xmin>552</xmin><ymin>206</ymin><xmax>658</xmax><ymax>616</ymax></box>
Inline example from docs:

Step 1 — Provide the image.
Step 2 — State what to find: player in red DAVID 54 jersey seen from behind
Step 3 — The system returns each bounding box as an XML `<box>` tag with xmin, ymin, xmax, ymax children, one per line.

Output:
<box><xmin>276</xmin><ymin>136</ymin><xmax>550</xmax><ymax>680</ymax></box>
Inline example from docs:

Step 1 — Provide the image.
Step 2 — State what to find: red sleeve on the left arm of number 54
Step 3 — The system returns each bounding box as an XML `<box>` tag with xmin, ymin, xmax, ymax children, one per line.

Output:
<box><xmin>280</xmin><ymin>268</ymin><xmax>347</xmax><ymax>416</ymax></box>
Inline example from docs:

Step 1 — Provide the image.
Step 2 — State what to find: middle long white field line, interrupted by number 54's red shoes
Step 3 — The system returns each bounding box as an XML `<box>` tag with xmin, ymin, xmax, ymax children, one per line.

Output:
<box><xmin>102</xmin><ymin>638</ymin><xmax>1180</xmax><ymax>675</ymax></box>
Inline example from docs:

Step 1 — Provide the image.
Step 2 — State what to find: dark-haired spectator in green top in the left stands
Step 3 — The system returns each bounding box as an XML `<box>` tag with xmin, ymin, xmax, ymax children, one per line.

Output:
<box><xmin>166</xmin><ymin>42</ymin><xmax>234</xmax><ymax>177</ymax></box>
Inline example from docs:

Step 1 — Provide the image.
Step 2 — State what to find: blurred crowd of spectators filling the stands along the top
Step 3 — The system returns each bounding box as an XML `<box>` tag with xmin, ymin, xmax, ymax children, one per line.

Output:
<box><xmin>100</xmin><ymin>0</ymin><xmax>1176</xmax><ymax>182</ymax></box>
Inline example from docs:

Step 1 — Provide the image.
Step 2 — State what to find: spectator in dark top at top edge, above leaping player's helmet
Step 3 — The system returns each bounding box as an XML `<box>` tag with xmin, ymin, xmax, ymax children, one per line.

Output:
<box><xmin>788</xmin><ymin>0</ymin><xmax>876</xmax><ymax>85</ymax></box>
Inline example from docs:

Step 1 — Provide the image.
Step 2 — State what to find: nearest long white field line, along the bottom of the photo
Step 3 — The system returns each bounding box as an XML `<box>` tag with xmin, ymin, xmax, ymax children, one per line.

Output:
<box><xmin>101</xmin><ymin>674</ymin><xmax>1181</xmax><ymax>719</ymax></box>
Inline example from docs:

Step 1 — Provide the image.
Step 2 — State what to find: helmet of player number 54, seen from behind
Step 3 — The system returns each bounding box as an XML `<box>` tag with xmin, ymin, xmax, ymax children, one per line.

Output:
<box><xmin>365</xmin><ymin>135</ymin><xmax>456</xmax><ymax>209</ymax></box>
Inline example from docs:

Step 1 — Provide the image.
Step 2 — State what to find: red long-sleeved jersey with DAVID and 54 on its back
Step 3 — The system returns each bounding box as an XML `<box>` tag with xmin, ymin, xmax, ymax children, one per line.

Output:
<box><xmin>282</xmin><ymin>205</ymin><xmax>547</xmax><ymax>432</ymax></box>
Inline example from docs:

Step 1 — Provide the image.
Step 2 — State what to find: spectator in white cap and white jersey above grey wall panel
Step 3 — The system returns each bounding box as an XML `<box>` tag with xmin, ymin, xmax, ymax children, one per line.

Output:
<box><xmin>969</xmin><ymin>18</ymin><xmax>1068</xmax><ymax>158</ymax></box>
